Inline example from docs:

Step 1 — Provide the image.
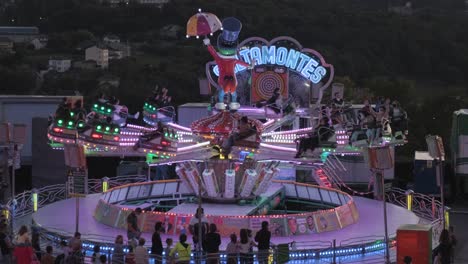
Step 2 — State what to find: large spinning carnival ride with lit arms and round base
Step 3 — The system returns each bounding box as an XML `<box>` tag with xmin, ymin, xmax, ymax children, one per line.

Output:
<box><xmin>36</xmin><ymin>11</ymin><xmax>417</xmax><ymax>258</ymax></box>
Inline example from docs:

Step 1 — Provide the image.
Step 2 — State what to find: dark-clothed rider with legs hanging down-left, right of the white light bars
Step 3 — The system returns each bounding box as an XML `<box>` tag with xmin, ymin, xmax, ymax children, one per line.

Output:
<box><xmin>295</xmin><ymin>117</ymin><xmax>334</xmax><ymax>158</ymax></box>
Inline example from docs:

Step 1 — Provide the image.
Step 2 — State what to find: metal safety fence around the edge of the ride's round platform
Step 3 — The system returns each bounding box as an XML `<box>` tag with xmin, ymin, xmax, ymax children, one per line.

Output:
<box><xmin>2</xmin><ymin>178</ymin><xmax>444</xmax><ymax>263</ymax></box>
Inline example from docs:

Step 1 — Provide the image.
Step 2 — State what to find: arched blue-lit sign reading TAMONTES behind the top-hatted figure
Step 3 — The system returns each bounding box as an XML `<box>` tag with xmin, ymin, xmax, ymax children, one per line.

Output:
<box><xmin>206</xmin><ymin>37</ymin><xmax>334</xmax><ymax>90</ymax></box>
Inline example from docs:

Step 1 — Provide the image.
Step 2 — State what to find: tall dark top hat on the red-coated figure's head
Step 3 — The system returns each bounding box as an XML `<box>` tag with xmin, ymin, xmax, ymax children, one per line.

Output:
<box><xmin>218</xmin><ymin>17</ymin><xmax>242</xmax><ymax>56</ymax></box>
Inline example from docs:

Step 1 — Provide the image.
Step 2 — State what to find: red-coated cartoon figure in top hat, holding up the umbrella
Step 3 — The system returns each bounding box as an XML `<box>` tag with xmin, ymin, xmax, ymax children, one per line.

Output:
<box><xmin>203</xmin><ymin>17</ymin><xmax>251</xmax><ymax>110</ymax></box>
